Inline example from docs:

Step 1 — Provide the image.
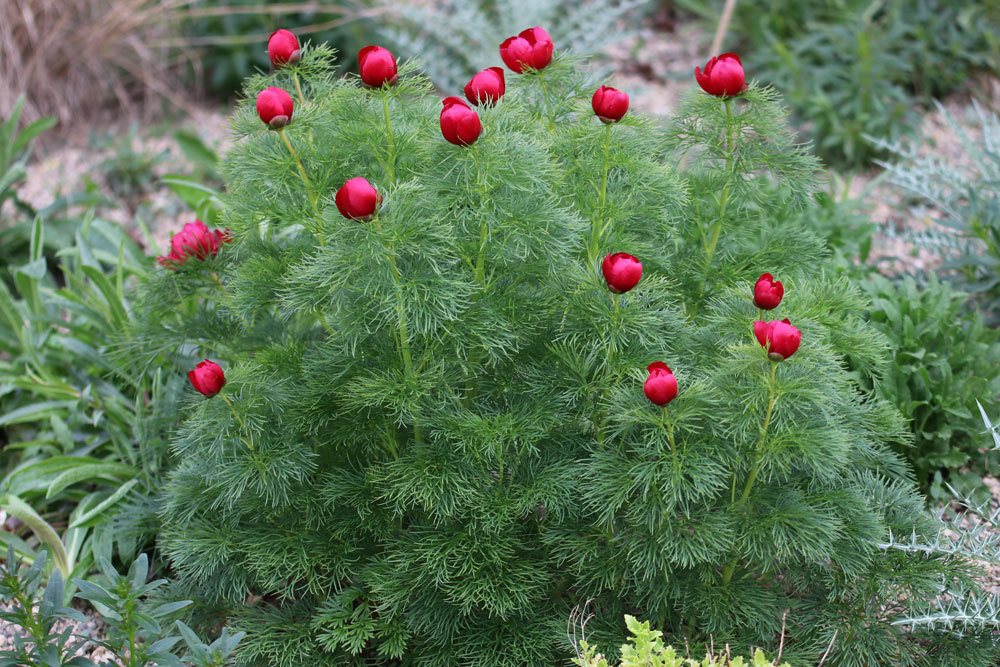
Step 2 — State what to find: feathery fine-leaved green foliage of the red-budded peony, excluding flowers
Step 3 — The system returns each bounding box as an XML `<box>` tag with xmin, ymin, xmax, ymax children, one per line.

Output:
<box><xmin>131</xmin><ymin>41</ymin><xmax>989</xmax><ymax>667</ymax></box>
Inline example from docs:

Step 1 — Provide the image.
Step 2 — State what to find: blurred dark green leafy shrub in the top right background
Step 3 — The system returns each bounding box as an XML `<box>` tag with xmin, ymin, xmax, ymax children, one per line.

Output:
<box><xmin>677</xmin><ymin>0</ymin><xmax>1000</xmax><ymax>166</ymax></box>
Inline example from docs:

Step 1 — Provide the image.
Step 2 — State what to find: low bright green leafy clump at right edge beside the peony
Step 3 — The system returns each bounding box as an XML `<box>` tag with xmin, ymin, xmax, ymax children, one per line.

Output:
<box><xmin>863</xmin><ymin>275</ymin><xmax>1000</xmax><ymax>500</ymax></box>
